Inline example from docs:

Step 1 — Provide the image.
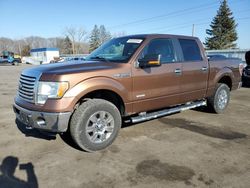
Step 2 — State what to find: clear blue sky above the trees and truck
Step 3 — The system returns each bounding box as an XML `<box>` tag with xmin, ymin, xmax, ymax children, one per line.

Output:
<box><xmin>0</xmin><ymin>0</ymin><xmax>250</xmax><ymax>49</ymax></box>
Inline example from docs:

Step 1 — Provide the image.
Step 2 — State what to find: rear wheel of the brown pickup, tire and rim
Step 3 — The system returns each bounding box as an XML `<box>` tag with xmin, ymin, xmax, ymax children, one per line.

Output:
<box><xmin>207</xmin><ymin>83</ymin><xmax>230</xmax><ymax>114</ymax></box>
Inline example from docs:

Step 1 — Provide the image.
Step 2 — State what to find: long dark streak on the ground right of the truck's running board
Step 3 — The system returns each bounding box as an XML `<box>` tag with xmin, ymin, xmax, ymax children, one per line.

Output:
<box><xmin>159</xmin><ymin>118</ymin><xmax>247</xmax><ymax>140</ymax></box>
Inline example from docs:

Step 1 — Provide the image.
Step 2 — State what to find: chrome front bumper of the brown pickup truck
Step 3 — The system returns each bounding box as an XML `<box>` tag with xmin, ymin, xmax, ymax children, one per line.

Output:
<box><xmin>13</xmin><ymin>104</ymin><xmax>72</xmax><ymax>133</ymax></box>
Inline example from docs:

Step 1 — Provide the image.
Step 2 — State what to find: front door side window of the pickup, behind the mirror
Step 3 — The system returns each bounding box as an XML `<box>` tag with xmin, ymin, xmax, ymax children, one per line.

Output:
<box><xmin>139</xmin><ymin>39</ymin><xmax>177</xmax><ymax>63</ymax></box>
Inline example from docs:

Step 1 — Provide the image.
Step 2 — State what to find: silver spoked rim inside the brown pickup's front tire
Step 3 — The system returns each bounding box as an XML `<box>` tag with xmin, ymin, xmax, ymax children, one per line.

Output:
<box><xmin>86</xmin><ymin>111</ymin><xmax>115</xmax><ymax>144</ymax></box>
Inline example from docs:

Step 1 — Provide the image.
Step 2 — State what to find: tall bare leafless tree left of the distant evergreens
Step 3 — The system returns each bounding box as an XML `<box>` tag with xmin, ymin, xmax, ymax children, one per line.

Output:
<box><xmin>64</xmin><ymin>26</ymin><xmax>87</xmax><ymax>54</ymax></box>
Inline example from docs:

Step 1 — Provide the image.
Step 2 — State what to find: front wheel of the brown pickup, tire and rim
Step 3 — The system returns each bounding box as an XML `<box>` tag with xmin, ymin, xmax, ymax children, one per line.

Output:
<box><xmin>70</xmin><ymin>99</ymin><xmax>121</xmax><ymax>152</ymax></box>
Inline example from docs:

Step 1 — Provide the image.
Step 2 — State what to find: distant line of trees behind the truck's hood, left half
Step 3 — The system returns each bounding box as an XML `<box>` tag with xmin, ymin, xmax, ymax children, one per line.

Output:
<box><xmin>0</xmin><ymin>25</ymin><xmax>125</xmax><ymax>56</ymax></box>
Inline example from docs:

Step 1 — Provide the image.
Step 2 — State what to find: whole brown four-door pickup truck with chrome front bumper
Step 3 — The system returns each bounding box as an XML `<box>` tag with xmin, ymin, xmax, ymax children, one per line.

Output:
<box><xmin>14</xmin><ymin>34</ymin><xmax>241</xmax><ymax>151</ymax></box>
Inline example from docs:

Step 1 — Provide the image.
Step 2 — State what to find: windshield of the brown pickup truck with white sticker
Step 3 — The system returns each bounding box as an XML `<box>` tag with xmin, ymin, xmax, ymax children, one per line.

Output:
<box><xmin>86</xmin><ymin>37</ymin><xmax>144</xmax><ymax>63</ymax></box>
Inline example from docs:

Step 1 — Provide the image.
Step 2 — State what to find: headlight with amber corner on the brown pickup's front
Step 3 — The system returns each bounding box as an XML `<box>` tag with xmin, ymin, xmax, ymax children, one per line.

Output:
<box><xmin>37</xmin><ymin>82</ymin><xmax>69</xmax><ymax>104</ymax></box>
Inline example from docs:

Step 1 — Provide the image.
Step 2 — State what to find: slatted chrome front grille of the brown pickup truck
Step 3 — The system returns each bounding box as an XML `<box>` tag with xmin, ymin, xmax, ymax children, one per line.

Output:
<box><xmin>18</xmin><ymin>74</ymin><xmax>36</xmax><ymax>103</ymax></box>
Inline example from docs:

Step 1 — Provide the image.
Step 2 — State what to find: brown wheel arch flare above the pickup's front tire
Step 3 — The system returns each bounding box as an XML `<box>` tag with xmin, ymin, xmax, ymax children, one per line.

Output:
<box><xmin>64</xmin><ymin>77</ymin><xmax>129</xmax><ymax>102</ymax></box>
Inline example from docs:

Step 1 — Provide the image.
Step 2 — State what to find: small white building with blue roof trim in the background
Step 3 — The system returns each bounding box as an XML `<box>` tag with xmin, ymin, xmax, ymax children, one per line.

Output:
<box><xmin>27</xmin><ymin>48</ymin><xmax>59</xmax><ymax>64</ymax></box>
